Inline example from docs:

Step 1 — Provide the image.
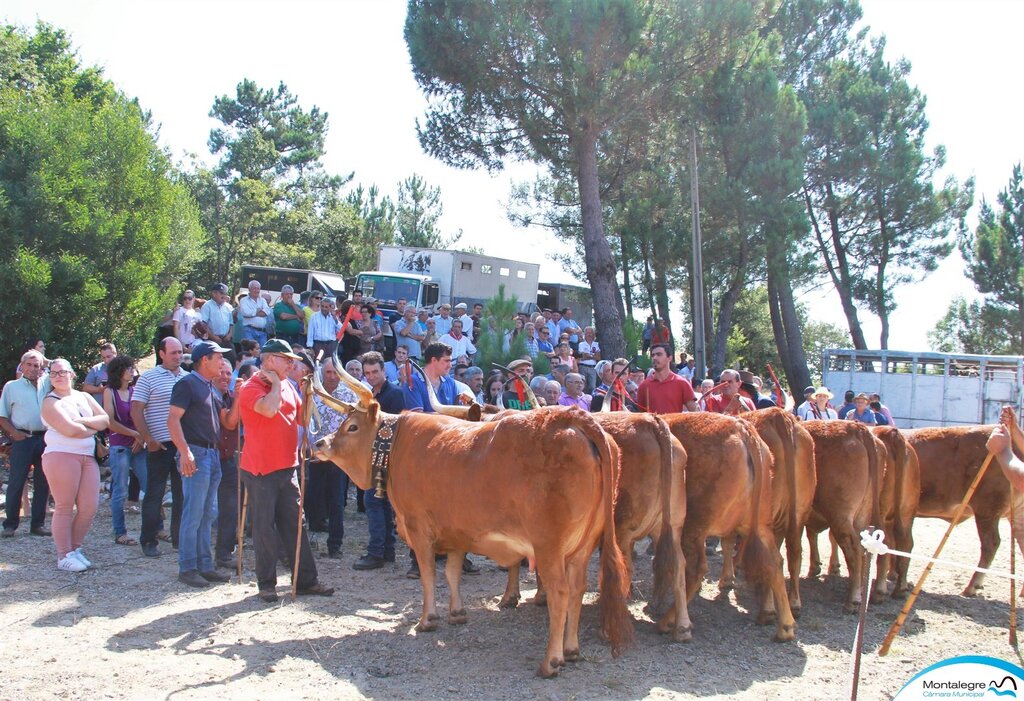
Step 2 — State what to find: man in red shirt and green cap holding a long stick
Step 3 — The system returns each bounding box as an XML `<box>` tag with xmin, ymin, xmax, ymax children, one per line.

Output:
<box><xmin>238</xmin><ymin>339</ymin><xmax>334</xmax><ymax>602</ymax></box>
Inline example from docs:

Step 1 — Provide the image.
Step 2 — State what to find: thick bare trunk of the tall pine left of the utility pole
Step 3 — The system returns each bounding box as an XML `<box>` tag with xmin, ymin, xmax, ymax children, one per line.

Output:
<box><xmin>575</xmin><ymin>132</ymin><xmax>626</xmax><ymax>358</ymax></box>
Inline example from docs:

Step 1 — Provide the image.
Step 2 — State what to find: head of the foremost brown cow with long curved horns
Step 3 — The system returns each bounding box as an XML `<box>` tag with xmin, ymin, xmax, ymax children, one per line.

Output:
<box><xmin>312</xmin><ymin>352</ymin><xmax>382</xmax><ymax>489</ymax></box>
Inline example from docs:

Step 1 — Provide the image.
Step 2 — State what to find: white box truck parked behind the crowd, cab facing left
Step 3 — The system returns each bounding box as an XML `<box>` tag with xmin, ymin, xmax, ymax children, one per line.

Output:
<box><xmin>352</xmin><ymin>246</ymin><xmax>541</xmax><ymax>312</ymax></box>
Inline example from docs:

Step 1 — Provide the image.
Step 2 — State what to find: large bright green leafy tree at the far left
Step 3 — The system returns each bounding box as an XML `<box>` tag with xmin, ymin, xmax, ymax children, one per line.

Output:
<box><xmin>0</xmin><ymin>25</ymin><xmax>202</xmax><ymax>368</ymax></box>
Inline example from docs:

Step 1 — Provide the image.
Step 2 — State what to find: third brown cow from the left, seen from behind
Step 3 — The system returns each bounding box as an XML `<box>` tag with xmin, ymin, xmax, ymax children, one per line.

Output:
<box><xmin>662</xmin><ymin>412</ymin><xmax>796</xmax><ymax>641</ymax></box>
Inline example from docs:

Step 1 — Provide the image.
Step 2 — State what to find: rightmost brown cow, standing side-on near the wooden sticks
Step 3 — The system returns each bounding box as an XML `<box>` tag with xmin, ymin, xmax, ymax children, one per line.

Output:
<box><xmin>905</xmin><ymin>425</ymin><xmax>1021</xmax><ymax>597</ymax></box>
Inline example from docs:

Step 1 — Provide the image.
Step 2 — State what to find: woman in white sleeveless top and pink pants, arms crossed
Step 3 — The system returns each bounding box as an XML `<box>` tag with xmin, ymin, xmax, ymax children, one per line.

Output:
<box><xmin>42</xmin><ymin>358</ymin><xmax>110</xmax><ymax>572</ymax></box>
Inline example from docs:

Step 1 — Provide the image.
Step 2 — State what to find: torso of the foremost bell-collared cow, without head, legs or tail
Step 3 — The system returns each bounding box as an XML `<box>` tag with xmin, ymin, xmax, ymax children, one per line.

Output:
<box><xmin>388</xmin><ymin>410</ymin><xmax>606</xmax><ymax>566</ymax></box>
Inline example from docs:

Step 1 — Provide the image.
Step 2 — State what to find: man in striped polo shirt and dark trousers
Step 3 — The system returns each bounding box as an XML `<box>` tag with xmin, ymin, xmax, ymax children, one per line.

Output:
<box><xmin>131</xmin><ymin>337</ymin><xmax>185</xmax><ymax>558</ymax></box>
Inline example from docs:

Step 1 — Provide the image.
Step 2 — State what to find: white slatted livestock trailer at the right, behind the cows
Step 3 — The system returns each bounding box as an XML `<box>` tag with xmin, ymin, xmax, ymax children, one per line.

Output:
<box><xmin>821</xmin><ymin>349</ymin><xmax>1024</xmax><ymax>429</ymax></box>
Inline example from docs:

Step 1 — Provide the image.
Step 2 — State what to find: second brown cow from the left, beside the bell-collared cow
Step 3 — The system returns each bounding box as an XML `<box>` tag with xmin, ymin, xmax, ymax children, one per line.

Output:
<box><xmin>499</xmin><ymin>408</ymin><xmax>692</xmax><ymax>642</ymax></box>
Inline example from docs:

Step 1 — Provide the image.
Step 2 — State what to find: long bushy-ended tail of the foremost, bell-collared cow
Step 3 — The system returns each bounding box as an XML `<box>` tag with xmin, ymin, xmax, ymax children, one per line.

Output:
<box><xmin>579</xmin><ymin>411</ymin><xmax>634</xmax><ymax>656</ymax></box>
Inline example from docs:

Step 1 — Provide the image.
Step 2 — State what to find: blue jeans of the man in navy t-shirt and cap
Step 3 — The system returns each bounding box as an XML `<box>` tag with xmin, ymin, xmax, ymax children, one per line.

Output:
<box><xmin>178</xmin><ymin>443</ymin><xmax>220</xmax><ymax>572</ymax></box>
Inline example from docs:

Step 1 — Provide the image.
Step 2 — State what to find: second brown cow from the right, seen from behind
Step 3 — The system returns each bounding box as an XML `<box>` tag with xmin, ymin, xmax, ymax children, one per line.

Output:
<box><xmin>872</xmin><ymin>426</ymin><xmax>921</xmax><ymax>597</ymax></box>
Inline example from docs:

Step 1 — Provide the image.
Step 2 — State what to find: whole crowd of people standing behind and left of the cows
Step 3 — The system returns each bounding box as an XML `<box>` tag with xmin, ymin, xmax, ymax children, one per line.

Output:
<box><xmin>0</xmin><ymin>280</ymin><xmax>995</xmax><ymax>602</ymax></box>
